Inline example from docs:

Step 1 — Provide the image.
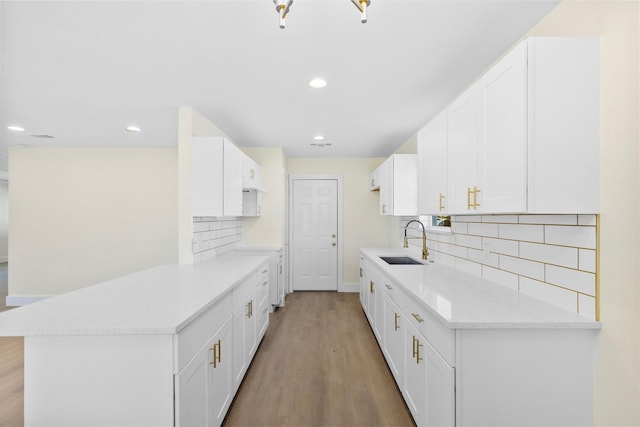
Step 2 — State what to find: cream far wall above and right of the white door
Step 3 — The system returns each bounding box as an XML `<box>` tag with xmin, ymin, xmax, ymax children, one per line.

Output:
<box><xmin>288</xmin><ymin>157</ymin><xmax>388</xmax><ymax>284</ymax></box>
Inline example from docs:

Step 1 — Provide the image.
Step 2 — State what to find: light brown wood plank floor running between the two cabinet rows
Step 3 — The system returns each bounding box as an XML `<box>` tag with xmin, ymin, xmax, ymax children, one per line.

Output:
<box><xmin>224</xmin><ymin>292</ymin><xmax>414</xmax><ymax>427</ymax></box>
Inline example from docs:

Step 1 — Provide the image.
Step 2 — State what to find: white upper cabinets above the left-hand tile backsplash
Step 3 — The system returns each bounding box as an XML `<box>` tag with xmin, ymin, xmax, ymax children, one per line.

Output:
<box><xmin>191</xmin><ymin>137</ymin><xmax>262</xmax><ymax>217</ymax></box>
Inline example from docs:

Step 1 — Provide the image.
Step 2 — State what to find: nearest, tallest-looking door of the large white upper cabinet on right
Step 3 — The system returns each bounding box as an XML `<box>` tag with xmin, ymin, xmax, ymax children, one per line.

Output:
<box><xmin>479</xmin><ymin>43</ymin><xmax>527</xmax><ymax>213</ymax></box>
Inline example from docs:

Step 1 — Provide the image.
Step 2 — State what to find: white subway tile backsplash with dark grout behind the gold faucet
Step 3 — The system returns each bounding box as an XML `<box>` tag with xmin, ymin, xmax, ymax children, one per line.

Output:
<box><xmin>400</xmin><ymin>215</ymin><xmax>597</xmax><ymax>319</ymax></box>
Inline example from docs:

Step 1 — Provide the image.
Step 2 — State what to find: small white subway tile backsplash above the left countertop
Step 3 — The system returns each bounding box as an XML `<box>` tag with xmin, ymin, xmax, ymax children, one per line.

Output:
<box><xmin>192</xmin><ymin>217</ymin><xmax>242</xmax><ymax>264</ymax></box>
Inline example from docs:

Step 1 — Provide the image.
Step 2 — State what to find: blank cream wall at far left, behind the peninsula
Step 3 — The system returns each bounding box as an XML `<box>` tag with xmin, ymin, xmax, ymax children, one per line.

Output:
<box><xmin>9</xmin><ymin>148</ymin><xmax>178</xmax><ymax>297</ymax></box>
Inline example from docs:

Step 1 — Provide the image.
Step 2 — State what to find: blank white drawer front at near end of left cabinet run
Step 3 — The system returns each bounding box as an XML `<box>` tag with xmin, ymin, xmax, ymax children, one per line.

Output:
<box><xmin>175</xmin><ymin>292</ymin><xmax>231</xmax><ymax>372</ymax></box>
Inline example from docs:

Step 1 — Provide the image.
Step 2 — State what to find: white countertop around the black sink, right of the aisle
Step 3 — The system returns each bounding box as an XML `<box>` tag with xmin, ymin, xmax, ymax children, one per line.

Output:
<box><xmin>361</xmin><ymin>248</ymin><xmax>601</xmax><ymax>329</ymax></box>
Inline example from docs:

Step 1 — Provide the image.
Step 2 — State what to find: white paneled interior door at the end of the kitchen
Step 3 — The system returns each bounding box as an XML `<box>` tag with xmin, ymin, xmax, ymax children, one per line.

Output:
<box><xmin>291</xmin><ymin>179</ymin><xmax>339</xmax><ymax>291</ymax></box>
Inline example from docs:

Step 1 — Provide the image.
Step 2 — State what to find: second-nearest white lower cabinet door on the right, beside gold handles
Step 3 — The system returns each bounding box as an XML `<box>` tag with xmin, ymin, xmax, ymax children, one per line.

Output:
<box><xmin>403</xmin><ymin>318</ymin><xmax>427</xmax><ymax>426</ymax></box>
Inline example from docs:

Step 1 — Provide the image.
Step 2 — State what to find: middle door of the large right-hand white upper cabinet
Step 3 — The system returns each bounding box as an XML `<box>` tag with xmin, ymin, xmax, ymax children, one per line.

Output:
<box><xmin>447</xmin><ymin>84</ymin><xmax>482</xmax><ymax>214</ymax></box>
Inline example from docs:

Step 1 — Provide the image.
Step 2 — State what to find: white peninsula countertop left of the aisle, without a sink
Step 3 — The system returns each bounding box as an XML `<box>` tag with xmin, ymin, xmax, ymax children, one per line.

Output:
<box><xmin>0</xmin><ymin>253</ymin><xmax>268</xmax><ymax>336</ymax></box>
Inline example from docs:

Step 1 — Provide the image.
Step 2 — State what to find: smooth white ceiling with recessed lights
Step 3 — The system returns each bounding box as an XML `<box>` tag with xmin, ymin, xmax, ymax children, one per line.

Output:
<box><xmin>0</xmin><ymin>0</ymin><xmax>558</xmax><ymax>171</ymax></box>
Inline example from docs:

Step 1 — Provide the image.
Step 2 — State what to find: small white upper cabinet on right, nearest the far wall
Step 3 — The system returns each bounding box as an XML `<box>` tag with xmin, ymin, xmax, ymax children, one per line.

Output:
<box><xmin>369</xmin><ymin>154</ymin><xmax>418</xmax><ymax>216</ymax></box>
